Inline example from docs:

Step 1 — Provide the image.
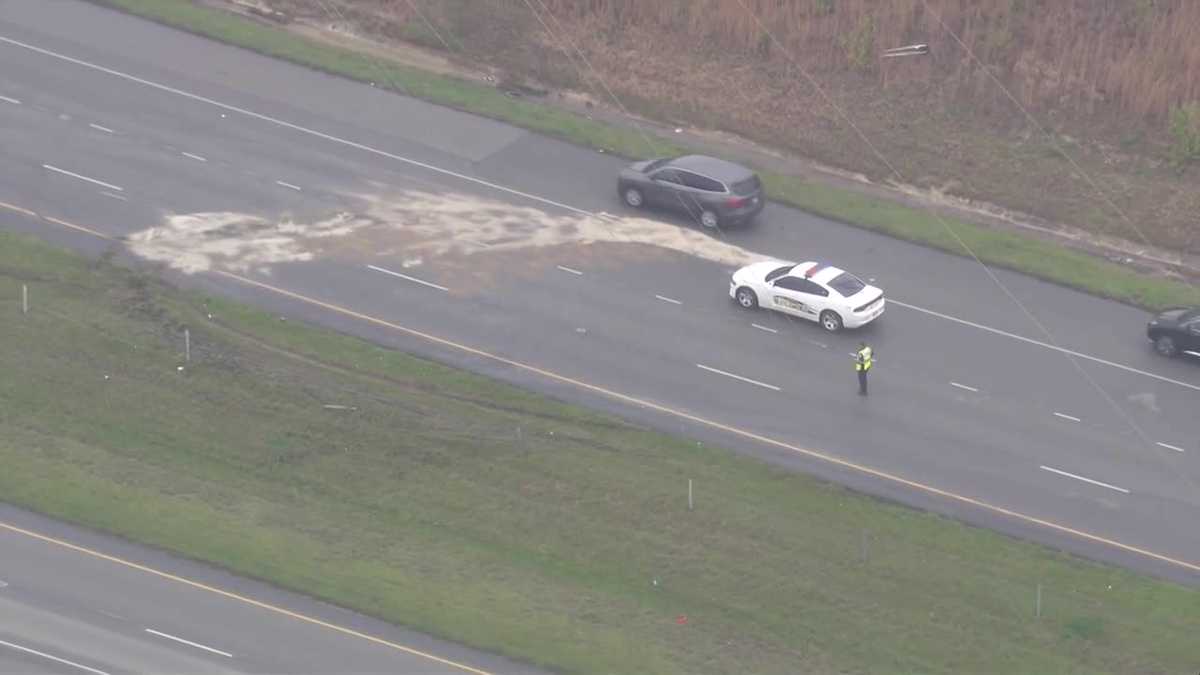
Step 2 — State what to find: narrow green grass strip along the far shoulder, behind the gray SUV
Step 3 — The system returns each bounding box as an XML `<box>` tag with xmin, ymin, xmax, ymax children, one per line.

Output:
<box><xmin>92</xmin><ymin>0</ymin><xmax>1200</xmax><ymax>310</ymax></box>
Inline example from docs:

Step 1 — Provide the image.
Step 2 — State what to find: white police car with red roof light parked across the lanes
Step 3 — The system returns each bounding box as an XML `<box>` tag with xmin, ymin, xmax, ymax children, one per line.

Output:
<box><xmin>730</xmin><ymin>261</ymin><xmax>884</xmax><ymax>331</ymax></box>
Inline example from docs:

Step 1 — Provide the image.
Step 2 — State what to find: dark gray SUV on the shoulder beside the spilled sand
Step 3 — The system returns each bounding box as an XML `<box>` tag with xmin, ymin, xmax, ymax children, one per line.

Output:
<box><xmin>617</xmin><ymin>155</ymin><xmax>763</xmax><ymax>228</ymax></box>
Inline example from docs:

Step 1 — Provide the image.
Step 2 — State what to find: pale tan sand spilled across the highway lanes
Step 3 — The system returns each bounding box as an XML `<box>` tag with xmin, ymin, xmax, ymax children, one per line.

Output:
<box><xmin>127</xmin><ymin>190</ymin><xmax>768</xmax><ymax>282</ymax></box>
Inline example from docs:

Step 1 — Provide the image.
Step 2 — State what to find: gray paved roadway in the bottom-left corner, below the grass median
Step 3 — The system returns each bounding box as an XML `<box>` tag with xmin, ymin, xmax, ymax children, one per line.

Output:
<box><xmin>0</xmin><ymin>507</ymin><xmax>535</xmax><ymax>675</ymax></box>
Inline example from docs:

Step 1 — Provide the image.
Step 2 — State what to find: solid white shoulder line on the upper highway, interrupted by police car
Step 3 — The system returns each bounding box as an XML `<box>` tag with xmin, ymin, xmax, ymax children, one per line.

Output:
<box><xmin>0</xmin><ymin>36</ymin><xmax>1200</xmax><ymax>392</ymax></box>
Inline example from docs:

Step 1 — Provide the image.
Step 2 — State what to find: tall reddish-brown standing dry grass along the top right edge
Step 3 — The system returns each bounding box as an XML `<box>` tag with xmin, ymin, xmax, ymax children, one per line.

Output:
<box><xmin>537</xmin><ymin>0</ymin><xmax>1200</xmax><ymax>119</ymax></box>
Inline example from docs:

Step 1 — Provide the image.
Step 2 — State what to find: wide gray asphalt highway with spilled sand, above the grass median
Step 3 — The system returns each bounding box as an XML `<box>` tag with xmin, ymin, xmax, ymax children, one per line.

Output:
<box><xmin>0</xmin><ymin>1</ymin><xmax>1200</xmax><ymax>598</ymax></box>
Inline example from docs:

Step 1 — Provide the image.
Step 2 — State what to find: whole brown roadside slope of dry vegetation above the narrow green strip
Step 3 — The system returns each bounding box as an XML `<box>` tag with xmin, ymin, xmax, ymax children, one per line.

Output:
<box><xmin>275</xmin><ymin>0</ymin><xmax>1200</xmax><ymax>252</ymax></box>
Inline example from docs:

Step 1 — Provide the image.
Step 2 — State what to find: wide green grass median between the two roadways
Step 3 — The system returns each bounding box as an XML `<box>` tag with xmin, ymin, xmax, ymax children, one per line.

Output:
<box><xmin>0</xmin><ymin>234</ymin><xmax>1200</xmax><ymax>675</ymax></box>
